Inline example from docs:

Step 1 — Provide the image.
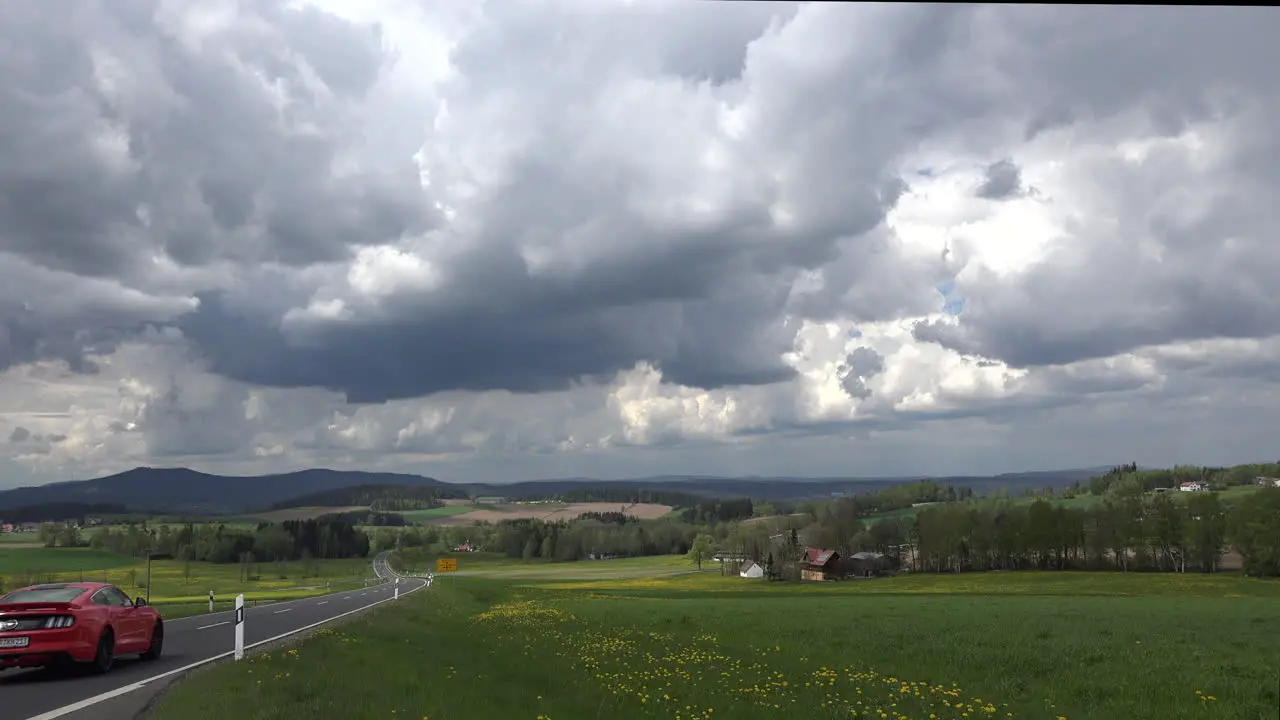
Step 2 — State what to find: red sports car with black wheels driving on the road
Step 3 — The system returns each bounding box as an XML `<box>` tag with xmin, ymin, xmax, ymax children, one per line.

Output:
<box><xmin>0</xmin><ymin>583</ymin><xmax>164</xmax><ymax>673</ymax></box>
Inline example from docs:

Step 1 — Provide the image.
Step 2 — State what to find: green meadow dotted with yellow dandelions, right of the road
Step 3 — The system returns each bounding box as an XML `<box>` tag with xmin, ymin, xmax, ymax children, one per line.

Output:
<box><xmin>147</xmin><ymin>559</ymin><xmax>1280</xmax><ymax>720</ymax></box>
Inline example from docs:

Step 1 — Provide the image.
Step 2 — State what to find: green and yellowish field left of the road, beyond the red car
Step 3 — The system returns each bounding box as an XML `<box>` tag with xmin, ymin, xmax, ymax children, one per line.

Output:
<box><xmin>0</xmin><ymin>547</ymin><xmax>372</xmax><ymax>616</ymax></box>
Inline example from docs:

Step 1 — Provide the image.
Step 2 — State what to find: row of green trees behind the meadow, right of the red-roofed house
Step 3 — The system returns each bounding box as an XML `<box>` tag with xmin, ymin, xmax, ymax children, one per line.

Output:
<box><xmin>809</xmin><ymin>479</ymin><xmax>1280</xmax><ymax>577</ymax></box>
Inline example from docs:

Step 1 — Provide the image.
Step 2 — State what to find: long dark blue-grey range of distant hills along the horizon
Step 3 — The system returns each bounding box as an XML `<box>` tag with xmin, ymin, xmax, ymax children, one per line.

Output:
<box><xmin>0</xmin><ymin>468</ymin><xmax>1101</xmax><ymax>516</ymax></box>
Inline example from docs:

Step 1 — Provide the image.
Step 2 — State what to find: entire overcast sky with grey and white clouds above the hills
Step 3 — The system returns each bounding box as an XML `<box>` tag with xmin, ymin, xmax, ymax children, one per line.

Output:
<box><xmin>0</xmin><ymin>0</ymin><xmax>1280</xmax><ymax>487</ymax></box>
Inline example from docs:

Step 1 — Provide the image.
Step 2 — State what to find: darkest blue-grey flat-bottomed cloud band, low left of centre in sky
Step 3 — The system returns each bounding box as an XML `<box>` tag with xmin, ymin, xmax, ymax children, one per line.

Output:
<box><xmin>180</xmin><ymin>279</ymin><xmax>791</xmax><ymax>402</ymax></box>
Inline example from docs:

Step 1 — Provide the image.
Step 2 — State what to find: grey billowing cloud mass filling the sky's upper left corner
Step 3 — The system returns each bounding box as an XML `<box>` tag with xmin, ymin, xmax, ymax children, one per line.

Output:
<box><xmin>0</xmin><ymin>0</ymin><xmax>436</xmax><ymax>370</ymax></box>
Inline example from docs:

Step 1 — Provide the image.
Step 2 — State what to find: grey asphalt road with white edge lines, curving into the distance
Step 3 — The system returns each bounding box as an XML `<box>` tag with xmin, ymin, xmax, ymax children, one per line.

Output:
<box><xmin>0</xmin><ymin>553</ymin><xmax>426</xmax><ymax>720</ymax></box>
